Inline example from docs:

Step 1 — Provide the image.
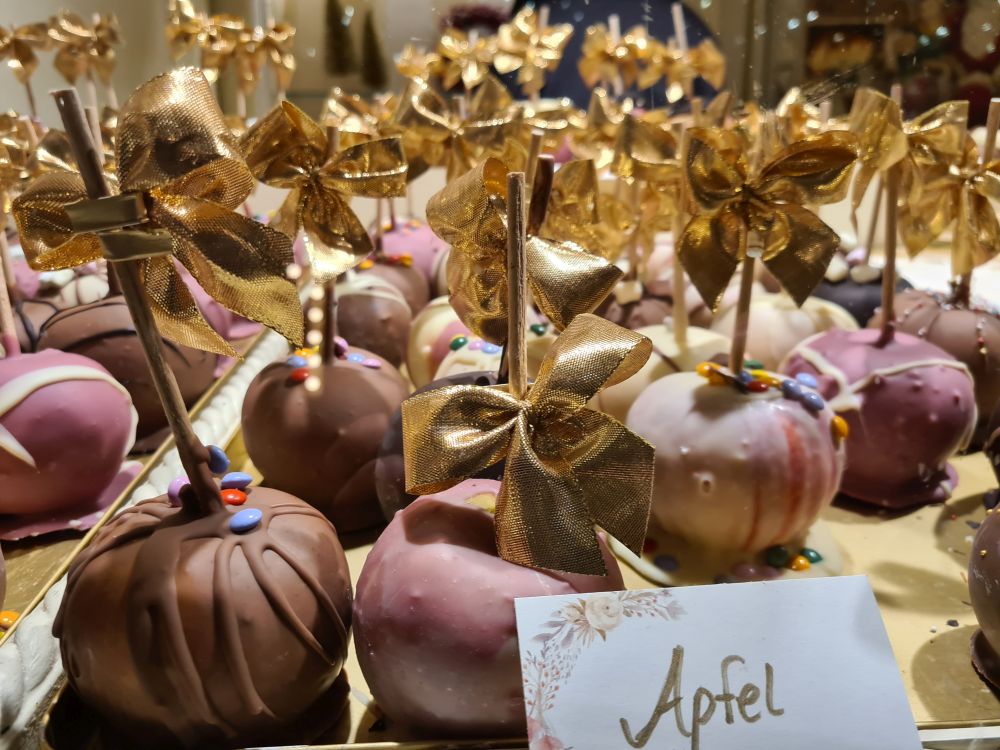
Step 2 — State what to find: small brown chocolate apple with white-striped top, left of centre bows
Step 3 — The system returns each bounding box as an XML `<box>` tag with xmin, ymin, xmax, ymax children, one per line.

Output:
<box><xmin>337</xmin><ymin>276</ymin><xmax>413</xmax><ymax>367</ymax></box>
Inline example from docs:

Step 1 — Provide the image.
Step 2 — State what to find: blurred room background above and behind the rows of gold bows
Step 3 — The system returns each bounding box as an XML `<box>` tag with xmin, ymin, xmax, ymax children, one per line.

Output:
<box><xmin>0</xmin><ymin>0</ymin><xmax>988</xmax><ymax>124</ymax></box>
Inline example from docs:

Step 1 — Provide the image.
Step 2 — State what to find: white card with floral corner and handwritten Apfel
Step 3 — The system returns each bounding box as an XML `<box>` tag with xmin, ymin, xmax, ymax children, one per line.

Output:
<box><xmin>514</xmin><ymin>576</ymin><xmax>921</xmax><ymax>750</ymax></box>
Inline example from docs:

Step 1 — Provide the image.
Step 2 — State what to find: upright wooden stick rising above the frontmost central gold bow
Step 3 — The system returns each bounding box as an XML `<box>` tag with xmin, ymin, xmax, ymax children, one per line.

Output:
<box><xmin>507</xmin><ymin>172</ymin><xmax>528</xmax><ymax>399</ymax></box>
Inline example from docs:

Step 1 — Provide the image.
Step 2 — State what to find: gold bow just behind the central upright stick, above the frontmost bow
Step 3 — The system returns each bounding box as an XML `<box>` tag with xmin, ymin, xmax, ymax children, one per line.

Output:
<box><xmin>427</xmin><ymin>158</ymin><xmax>621</xmax><ymax>343</ymax></box>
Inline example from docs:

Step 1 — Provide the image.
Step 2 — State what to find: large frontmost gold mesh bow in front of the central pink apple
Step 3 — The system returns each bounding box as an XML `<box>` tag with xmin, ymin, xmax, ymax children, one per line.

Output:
<box><xmin>403</xmin><ymin>315</ymin><xmax>653</xmax><ymax>575</ymax></box>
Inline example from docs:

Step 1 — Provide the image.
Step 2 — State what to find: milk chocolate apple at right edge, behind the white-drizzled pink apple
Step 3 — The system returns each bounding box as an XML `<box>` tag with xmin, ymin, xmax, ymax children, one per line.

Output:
<box><xmin>869</xmin><ymin>289</ymin><xmax>1000</xmax><ymax>449</ymax></box>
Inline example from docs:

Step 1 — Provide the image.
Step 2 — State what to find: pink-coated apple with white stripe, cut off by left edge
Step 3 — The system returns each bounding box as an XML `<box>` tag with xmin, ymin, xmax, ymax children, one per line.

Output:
<box><xmin>0</xmin><ymin>349</ymin><xmax>136</xmax><ymax>514</ymax></box>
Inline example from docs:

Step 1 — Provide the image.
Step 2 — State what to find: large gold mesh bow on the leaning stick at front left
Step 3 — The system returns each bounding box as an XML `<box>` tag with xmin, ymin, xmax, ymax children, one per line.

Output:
<box><xmin>14</xmin><ymin>68</ymin><xmax>303</xmax><ymax>356</ymax></box>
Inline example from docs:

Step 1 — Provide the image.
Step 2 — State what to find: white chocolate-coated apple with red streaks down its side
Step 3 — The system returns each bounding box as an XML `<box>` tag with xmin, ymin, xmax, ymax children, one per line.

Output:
<box><xmin>626</xmin><ymin>372</ymin><xmax>845</xmax><ymax>553</ymax></box>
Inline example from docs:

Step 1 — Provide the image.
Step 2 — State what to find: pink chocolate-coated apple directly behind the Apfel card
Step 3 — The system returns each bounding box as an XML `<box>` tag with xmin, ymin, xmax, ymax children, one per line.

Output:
<box><xmin>354</xmin><ymin>479</ymin><xmax>624</xmax><ymax>737</ymax></box>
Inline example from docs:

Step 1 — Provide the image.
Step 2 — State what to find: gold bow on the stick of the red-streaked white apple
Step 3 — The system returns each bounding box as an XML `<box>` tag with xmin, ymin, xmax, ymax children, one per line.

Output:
<box><xmin>679</xmin><ymin>128</ymin><xmax>857</xmax><ymax>310</ymax></box>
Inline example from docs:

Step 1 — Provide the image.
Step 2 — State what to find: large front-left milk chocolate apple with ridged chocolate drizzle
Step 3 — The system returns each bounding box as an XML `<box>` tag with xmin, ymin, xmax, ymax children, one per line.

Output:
<box><xmin>53</xmin><ymin>488</ymin><xmax>351</xmax><ymax>748</ymax></box>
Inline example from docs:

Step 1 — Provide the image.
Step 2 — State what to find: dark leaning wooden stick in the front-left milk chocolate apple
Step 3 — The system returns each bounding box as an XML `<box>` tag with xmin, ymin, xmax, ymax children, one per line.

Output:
<box><xmin>52</xmin><ymin>89</ymin><xmax>223</xmax><ymax>515</ymax></box>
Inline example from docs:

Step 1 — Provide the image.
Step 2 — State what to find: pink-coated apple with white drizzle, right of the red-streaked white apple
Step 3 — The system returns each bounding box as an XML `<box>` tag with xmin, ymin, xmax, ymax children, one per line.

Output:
<box><xmin>781</xmin><ymin>329</ymin><xmax>976</xmax><ymax>508</ymax></box>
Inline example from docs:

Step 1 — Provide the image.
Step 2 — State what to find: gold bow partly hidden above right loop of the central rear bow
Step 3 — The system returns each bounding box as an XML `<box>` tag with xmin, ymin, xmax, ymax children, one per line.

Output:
<box><xmin>539</xmin><ymin>159</ymin><xmax>635</xmax><ymax>263</ymax></box>
